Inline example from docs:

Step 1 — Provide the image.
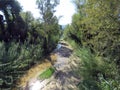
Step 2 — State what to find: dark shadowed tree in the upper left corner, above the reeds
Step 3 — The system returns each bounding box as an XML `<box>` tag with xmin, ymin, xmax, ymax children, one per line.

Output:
<box><xmin>0</xmin><ymin>0</ymin><xmax>27</xmax><ymax>41</ymax></box>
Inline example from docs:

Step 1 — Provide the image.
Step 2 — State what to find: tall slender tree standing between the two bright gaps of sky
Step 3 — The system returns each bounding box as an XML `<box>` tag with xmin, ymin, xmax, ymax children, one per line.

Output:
<box><xmin>36</xmin><ymin>0</ymin><xmax>60</xmax><ymax>54</ymax></box>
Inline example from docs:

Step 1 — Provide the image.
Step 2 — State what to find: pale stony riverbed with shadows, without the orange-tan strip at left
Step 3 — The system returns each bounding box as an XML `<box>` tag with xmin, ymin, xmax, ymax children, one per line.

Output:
<box><xmin>24</xmin><ymin>42</ymin><xmax>80</xmax><ymax>90</ymax></box>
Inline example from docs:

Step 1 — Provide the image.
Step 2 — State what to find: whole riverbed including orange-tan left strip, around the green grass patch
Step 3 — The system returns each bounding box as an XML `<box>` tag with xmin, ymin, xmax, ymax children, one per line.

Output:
<box><xmin>17</xmin><ymin>42</ymin><xmax>80</xmax><ymax>90</ymax></box>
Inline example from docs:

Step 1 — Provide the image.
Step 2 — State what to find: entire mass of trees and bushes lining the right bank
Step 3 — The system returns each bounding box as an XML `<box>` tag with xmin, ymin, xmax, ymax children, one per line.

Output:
<box><xmin>64</xmin><ymin>0</ymin><xmax>120</xmax><ymax>90</ymax></box>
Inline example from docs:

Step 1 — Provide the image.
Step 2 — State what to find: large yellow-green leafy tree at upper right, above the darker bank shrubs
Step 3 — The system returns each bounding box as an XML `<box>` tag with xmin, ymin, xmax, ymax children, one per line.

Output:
<box><xmin>72</xmin><ymin>0</ymin><xmax>120</xmax><ymax>58</ymax></box>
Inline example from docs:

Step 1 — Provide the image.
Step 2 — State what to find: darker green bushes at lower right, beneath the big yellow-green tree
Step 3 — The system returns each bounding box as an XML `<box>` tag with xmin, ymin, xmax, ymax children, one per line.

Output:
<box><xmin>75</xmin><ymin>48</ymin><xmax>120</xmax><ymax>90</ymax></box>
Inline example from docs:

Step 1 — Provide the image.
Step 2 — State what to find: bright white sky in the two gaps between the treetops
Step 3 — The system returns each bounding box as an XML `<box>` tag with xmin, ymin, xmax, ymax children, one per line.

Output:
<box><xmin>18</xmin><ymin>0</ymin><xmax>75</xmax><ymax>25</ymax></box>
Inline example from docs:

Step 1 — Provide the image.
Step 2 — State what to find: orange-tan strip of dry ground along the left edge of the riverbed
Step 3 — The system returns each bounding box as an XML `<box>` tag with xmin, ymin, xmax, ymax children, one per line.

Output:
<box><xmin>18</xmin><ymin>54</ymin><xmax>57</xmax><ymax>87</ymax></box>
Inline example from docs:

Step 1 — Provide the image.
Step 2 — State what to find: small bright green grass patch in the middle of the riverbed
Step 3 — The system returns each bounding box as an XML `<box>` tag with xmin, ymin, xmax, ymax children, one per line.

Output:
<box><xmin>38</xmin><ymin>67</ymin><xmax>55</xmax><ymax>79</ymax></box>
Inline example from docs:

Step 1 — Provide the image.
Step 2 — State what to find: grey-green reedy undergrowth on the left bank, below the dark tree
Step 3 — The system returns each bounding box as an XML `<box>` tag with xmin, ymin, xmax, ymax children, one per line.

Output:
<box><xmin>0</xmin><ymin>42</ymin><xmax>42</xmax><ymax>88</ymax></box>
